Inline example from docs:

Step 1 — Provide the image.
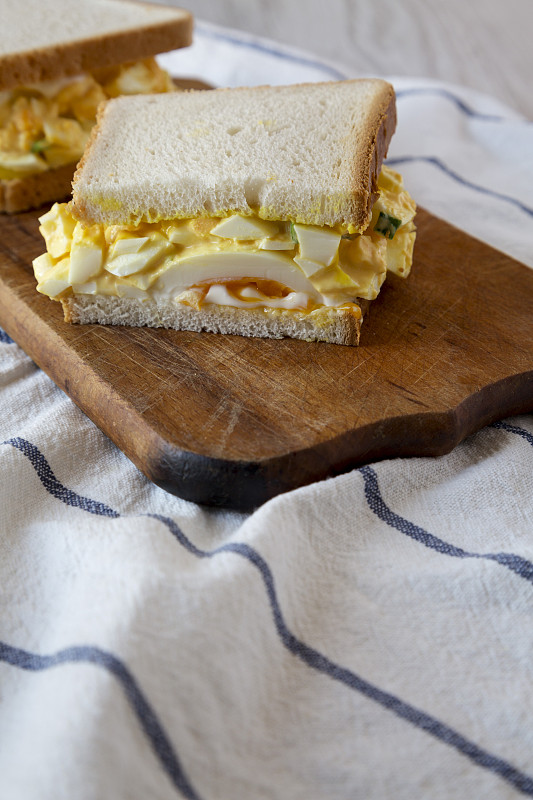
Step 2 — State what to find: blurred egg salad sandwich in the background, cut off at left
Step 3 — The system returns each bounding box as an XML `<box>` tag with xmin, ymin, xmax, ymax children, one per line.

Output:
<box><xmin>0</xmin><ymin>0</ymin><xmax>192</xmax><ymax>213</ymax></box>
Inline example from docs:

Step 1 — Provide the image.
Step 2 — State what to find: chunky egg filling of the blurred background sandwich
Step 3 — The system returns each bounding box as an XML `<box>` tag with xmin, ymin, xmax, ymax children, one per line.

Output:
<box><xmin>0</xmin><ymin>58</ymin><xmax>175</xmax><ymax>180</ymax></box>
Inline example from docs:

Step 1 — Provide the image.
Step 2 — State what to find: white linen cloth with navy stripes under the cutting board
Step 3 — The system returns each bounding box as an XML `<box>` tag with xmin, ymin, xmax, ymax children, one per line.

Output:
<box><xmin>0</xmin><ymin>24</ymin><xmax>533</xmax><ymax>800</ymax></box>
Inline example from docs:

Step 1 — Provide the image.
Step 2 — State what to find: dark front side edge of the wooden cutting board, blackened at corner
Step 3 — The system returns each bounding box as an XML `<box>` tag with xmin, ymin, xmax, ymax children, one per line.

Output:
<box><xmin>145</xmin><ymin>371</ymin><xmax>533</xmax><ymax>511</ymax></box>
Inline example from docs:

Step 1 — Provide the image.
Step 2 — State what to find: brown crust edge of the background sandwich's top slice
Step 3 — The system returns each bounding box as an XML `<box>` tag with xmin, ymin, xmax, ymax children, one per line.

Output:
<box><xmin>0</xmin><ymin>0</ymin><xmax>193</xmax><ymax>90</ymax></box>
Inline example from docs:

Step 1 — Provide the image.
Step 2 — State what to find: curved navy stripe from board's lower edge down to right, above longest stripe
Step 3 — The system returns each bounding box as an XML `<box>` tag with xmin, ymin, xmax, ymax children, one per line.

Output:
<box><xmin>359</xmin><ymin>466</ymin><xmax>533</xmax><ymax>583</ymax></box>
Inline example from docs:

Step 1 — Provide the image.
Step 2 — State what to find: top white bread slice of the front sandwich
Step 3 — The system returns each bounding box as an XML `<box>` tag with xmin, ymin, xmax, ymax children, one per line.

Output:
<box><xmin>70</xmin><ymin>79</ymin><xmax>396</xmax><ymax>233</ymax></box>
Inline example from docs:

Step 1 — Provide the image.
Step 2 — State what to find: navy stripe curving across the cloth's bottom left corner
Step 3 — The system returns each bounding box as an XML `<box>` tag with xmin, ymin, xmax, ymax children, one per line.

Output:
<box><xmin>0</xmin><ymin>642</ymin><xmax>199</xmax><ymax>800</ymax></box>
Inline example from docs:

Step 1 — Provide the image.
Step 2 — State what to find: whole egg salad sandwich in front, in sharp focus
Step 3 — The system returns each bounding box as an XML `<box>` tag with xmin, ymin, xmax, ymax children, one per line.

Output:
<box><xmin>34</xmin><ymin>79</ymin><xmax>415</xmax><ymax>345</ymax></box>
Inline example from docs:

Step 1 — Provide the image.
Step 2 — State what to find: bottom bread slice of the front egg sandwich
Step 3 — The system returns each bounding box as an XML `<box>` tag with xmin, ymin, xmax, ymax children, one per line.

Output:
<box><xmin>61</xmin><ymin>295</ymin><xmax>369</xmax><ymax>345</ymax></box>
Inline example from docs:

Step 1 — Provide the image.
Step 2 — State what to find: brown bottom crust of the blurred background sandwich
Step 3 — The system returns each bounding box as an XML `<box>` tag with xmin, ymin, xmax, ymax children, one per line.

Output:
<box><xmin>0</xmin><ymin>164</ymin><xmax>76</xmax><ymax>214</ymax></box>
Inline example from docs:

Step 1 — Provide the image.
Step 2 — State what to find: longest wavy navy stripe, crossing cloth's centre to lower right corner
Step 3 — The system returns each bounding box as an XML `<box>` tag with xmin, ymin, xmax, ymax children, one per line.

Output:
<box><xmin>4</xmin><ymin>438</ymin><xmax>533</xmax><ymax>796</ymax></box>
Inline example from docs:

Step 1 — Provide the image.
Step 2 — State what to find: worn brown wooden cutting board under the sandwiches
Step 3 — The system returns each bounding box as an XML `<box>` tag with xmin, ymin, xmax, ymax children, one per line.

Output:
<box><xmin>0</xmin><ymin>203</ymin><xmax>533</xmax><ymax>509</ymax></box>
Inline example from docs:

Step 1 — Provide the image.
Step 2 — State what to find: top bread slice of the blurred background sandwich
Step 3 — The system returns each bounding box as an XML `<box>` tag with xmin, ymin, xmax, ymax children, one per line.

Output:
<box><xmin>0</xmin><ymin>0</ymin><xmax>192</xmax><ymax>90</ymax></box>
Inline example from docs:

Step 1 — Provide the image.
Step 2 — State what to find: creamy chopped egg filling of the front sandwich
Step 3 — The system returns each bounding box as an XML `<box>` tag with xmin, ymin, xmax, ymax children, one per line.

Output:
<box><xmin>33</xmin><ymin>167</ymin><xmax>416</xmax><ymax>316</ymax></box>
